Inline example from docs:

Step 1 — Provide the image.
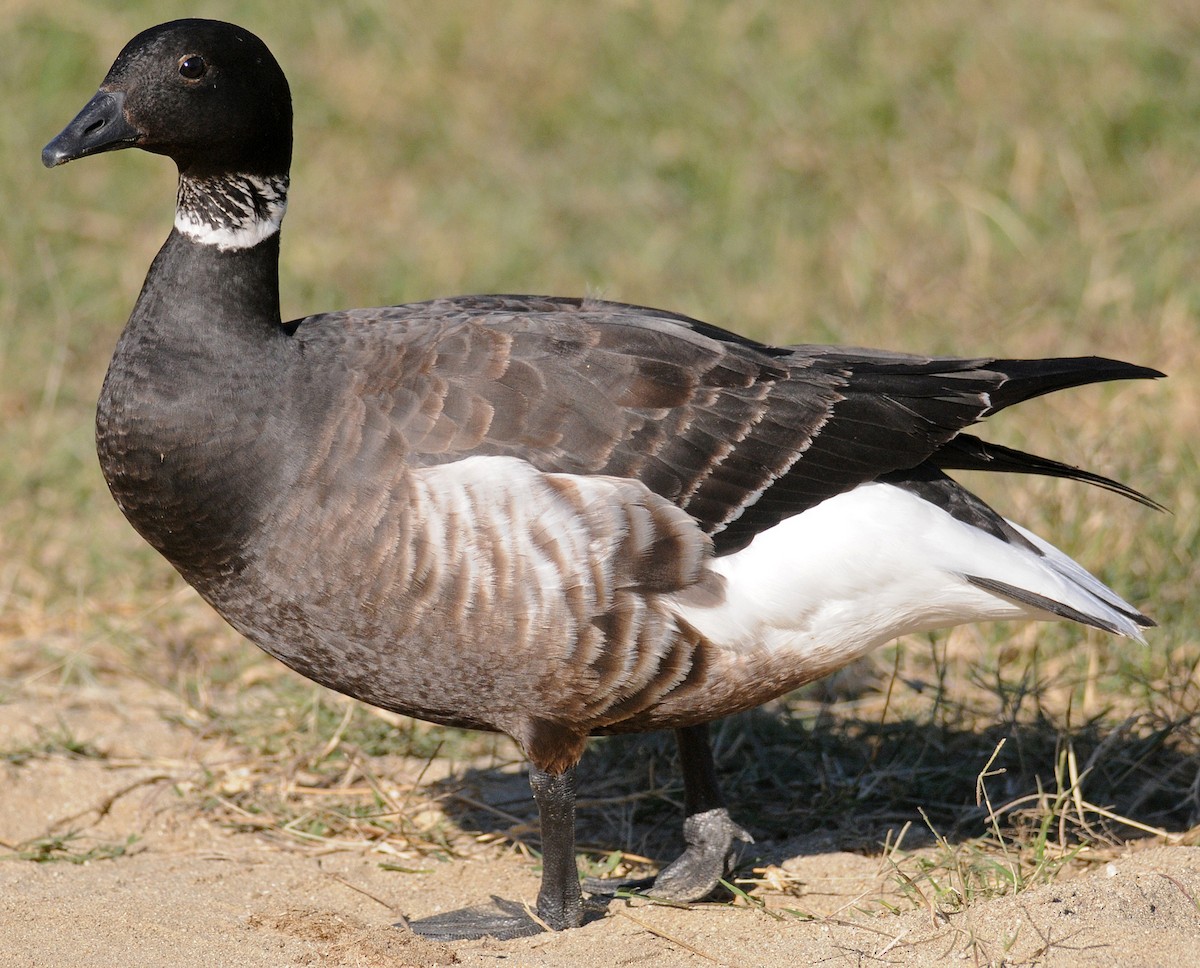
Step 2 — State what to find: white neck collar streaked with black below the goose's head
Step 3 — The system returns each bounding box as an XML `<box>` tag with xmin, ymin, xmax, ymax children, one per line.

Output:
<box><xmin>175</xmin><ymin>175</ymin><xmax>288</xmax><ymax>252</ymax></box>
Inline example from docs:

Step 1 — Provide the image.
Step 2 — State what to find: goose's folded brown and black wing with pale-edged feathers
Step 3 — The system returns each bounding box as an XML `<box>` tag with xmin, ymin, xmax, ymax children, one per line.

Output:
<box><xmin>290</xmin><ymin>296</ymin><xmax>1153</xmax><ymax>554</ymax></box>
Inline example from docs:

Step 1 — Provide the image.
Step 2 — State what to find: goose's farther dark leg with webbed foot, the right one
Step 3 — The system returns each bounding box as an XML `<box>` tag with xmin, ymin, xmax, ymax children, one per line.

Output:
<box><xmin>583</xmin><ymin>723</ymin><xmax>754</xmax><ymax>901</ymax></box>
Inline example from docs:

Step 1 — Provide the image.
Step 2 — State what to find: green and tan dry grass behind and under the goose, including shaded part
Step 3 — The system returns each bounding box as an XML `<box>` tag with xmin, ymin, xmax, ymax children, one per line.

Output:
<box><xmin>0</xmin><ymin>0</ymin><xmax>1200</xmax><ymax>915</ymax></box>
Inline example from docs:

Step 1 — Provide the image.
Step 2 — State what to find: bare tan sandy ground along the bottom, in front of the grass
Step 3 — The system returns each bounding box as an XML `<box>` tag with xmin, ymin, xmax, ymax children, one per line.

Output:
<box><xmin>0</xmin><ymin>681</ymin><xmax>1200</xmax><ymax>968</ymax></box>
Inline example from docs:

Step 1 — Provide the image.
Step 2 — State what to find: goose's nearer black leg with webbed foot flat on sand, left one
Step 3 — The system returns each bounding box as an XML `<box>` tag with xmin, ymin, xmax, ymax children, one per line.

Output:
<box><xmin>409</xmin><ymin>765</ymin><xmax>583</xmax><ymax>942</ymax></box>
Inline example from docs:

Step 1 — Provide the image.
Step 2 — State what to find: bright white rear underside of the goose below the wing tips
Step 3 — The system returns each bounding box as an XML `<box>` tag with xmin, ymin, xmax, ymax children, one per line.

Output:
<box><xmin>673</xmin><ymin>483</ymin><xmax>1141</xmax><ymax>666</ymax></box>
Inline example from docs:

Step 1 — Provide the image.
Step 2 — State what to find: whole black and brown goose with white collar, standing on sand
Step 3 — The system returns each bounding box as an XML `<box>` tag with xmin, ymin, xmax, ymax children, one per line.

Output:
<box><xmin>42</xmin><ymin>20</ymin><xmax>1162</xmax><ymax>937</ymax></box>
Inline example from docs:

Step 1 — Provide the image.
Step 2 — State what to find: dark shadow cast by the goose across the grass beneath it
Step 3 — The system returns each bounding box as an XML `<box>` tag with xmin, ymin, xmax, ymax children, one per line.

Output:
<box><xmin>430</xmin><ymin>703</ymin><xmax>1200</xmax><ymax>882</ymax></box>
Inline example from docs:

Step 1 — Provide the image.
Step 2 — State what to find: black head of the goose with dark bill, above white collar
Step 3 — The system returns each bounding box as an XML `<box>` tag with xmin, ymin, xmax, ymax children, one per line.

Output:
<box><xmin>42</xmin><ymin>20</ymin><xmax>292</xmax><ymax>176</ymax></box>
